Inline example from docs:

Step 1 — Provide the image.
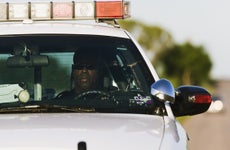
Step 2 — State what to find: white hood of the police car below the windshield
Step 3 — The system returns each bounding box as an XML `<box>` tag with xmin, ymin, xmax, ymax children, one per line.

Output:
<box><xmin>0</xmin><ymin>113</ymin><xmax>164</xmax><ymax>150</ymax></box>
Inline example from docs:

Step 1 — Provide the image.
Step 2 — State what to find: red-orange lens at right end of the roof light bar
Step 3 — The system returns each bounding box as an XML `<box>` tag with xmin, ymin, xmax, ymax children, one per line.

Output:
<box><xmin>96</xmin><ymin>1</ymin><xmax>123</xmax><ymax>18</ymax></box>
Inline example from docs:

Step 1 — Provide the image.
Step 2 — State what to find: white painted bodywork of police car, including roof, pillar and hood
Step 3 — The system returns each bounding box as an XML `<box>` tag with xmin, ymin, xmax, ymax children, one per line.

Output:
<box><xmin>0</xmin><ymin>0</ymin><xmax>210</xmax><ymax>150</ymax></box>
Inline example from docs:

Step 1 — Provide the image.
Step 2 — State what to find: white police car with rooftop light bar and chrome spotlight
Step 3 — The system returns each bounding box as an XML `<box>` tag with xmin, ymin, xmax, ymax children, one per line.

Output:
<box><xmin>0</xmin><ymin>0</ymin><xmax>211</xmax><ymax>150</ymax></box>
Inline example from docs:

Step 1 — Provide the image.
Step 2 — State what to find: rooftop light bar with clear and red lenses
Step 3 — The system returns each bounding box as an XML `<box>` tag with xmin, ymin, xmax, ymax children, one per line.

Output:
<box><xmin>0</xmin><ymin>0</ymin><xmax>130</xmax><ymax>21</ymax></box>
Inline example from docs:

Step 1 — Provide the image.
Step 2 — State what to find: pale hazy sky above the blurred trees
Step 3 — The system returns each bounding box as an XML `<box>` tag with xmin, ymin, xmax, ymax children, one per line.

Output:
<box><xmin>129</xmin><ymin>0</ymin><xmax>230</xmax><ymax>79</ymax></box>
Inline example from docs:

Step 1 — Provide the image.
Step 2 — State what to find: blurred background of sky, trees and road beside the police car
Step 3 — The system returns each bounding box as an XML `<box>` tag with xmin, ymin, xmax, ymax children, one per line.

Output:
<box><xmin>119</xmin><ymin>0</ymin><xmax>230</xmax><ymax>150</ymax></box>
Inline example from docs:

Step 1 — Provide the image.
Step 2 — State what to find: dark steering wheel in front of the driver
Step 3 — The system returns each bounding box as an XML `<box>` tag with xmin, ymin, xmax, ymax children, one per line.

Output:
<box><xmin>74</xmin><ymin>90</ymin><xmax>110</xmax><ymax>100</ymax></box>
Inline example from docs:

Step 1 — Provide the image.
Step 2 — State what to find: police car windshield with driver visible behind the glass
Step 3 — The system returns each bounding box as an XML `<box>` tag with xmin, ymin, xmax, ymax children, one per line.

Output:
<box><xmin>0</xmin><ymin>35</ymin><xmax>161</xmax><ymax>114</ymax></box>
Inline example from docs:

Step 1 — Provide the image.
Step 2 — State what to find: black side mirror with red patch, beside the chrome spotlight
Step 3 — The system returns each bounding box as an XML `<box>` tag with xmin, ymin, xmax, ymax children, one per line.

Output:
<box><xmin>171</xmin><ymin>86</ymin><xmax>211</xmax><ymax>117</ymax></box>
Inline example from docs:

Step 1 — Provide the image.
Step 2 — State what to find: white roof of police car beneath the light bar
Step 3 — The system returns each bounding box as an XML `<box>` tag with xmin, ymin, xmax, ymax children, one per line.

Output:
<box><xmin>0</xmin><ymin>21</ymin><xmax>128</xmax><ymax>38</ymax></box>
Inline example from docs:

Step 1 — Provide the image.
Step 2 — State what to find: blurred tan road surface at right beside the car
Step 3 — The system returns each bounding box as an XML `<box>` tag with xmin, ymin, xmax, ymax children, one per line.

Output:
<box><xmin>183</xmin><ymin>80</ymin><xmax>230</xmax><ymax>150</ymax></box>
